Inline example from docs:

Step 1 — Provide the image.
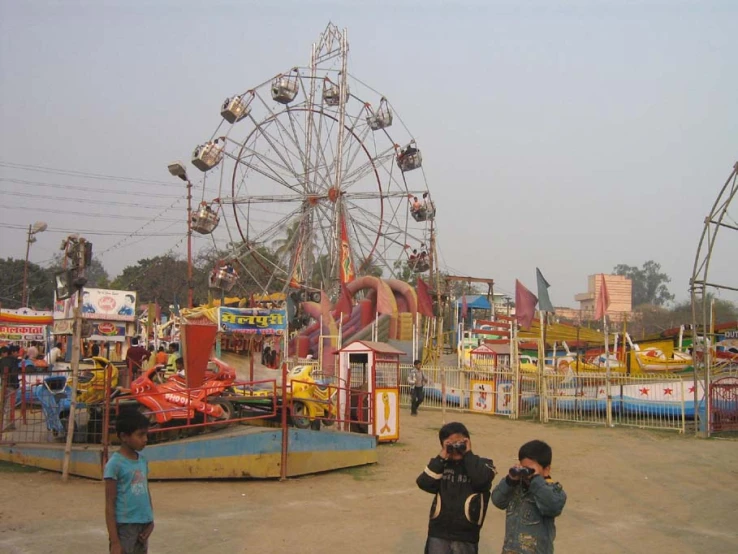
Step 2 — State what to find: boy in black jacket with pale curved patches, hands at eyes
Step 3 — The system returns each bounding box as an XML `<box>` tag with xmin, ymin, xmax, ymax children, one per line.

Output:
<box><xmin>416</xmin><ymin>422</ymin><xmax>495</xmax><ymax>554</ymax></box>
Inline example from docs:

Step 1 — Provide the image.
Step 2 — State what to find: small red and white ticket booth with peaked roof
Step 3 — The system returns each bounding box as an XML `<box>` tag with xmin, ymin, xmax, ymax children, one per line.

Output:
<box><xmin>338</xmin><ymin>340</ymin><xmax>404</xmax><ymax>442</ymax></box>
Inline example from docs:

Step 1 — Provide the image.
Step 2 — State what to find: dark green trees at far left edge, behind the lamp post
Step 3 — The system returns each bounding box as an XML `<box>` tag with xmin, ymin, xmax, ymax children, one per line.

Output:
<box><xmin>0</xmin><ymin>258</ymin><xmax>54</xmax><ymax>310</ymax></box>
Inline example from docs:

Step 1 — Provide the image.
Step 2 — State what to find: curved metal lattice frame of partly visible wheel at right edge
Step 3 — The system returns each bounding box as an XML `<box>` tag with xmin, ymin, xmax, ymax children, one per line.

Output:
<box><xmin>689</xmin><ymin>158</ymin><xmax>738</xmax><ymax>437</ymax></box>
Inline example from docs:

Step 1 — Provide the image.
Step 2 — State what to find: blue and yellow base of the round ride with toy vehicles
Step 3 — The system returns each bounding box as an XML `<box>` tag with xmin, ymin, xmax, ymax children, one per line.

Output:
<box><xmin>0</xmin><ymin>425</ymin><xmax>377</xmax><ymax>480</ymax></box>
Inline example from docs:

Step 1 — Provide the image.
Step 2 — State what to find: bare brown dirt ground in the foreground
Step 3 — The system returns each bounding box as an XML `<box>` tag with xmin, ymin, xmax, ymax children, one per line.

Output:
<box><xmin>0</xmin><ymin>409</ymin><xmax>738</xmax><ymax>554</ymax></box>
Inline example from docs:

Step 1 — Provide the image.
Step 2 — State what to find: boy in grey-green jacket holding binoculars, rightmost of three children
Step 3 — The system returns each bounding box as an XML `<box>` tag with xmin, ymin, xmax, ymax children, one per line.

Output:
<box><xmin>492</xmin><ymin>440</ymin><xmax>566</xmax><ymax>554</ymax></box>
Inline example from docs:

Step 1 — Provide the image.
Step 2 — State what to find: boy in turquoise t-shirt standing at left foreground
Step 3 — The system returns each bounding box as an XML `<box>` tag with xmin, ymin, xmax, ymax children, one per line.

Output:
<box><xmin>104</xmin><ymin>410</ymin><xmax>154</xmax><ymax>554</ymax></box>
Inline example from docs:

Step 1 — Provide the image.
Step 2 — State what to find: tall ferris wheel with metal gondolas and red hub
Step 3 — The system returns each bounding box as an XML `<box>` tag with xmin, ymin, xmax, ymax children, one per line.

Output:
<box><xmin>187</xmin><ymin>24</ymin><xmax>435</xmax><ymax>290</ymax></box>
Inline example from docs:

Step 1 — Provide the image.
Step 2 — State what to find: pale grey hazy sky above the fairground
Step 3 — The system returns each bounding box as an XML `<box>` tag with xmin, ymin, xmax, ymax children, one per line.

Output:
<box><xmin>0</xmin><ymin>0</ymin><xmax>738</xmax><ymax>306</ymax></box>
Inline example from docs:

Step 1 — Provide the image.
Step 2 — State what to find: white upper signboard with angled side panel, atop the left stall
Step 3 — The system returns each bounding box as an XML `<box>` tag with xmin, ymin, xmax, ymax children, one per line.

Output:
<box><xmin>54</xmin><ymin>289</ymin><xmax>136</xmax><ymax>321</ymax></box>
